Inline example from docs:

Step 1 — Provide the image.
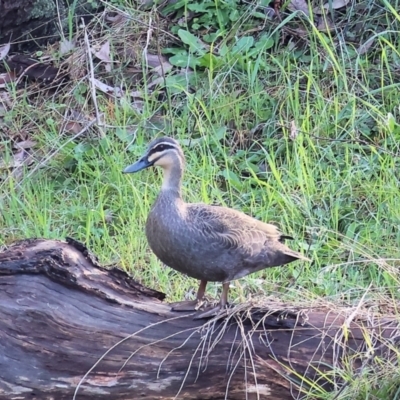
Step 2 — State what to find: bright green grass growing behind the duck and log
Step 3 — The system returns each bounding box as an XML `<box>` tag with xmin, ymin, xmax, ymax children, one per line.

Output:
<box><xmin>0</xmin><ymin>1</ymin><xmax>400</xmax><ymax>399</ymax></box>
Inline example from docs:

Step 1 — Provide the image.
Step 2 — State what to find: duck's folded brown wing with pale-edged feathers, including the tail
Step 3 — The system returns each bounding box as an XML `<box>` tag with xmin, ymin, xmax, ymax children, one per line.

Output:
<box><xmin>187</xmin><ymin>204</ymin><xmax>310</xmax><ymax>281</ymax></box>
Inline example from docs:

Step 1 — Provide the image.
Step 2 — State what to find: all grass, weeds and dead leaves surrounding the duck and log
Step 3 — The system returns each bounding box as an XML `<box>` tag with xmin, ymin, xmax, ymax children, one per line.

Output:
<box><xmin>0</xmin><ymin>0</ymin><xmax>400</xmax><ymax>400</ymax></box>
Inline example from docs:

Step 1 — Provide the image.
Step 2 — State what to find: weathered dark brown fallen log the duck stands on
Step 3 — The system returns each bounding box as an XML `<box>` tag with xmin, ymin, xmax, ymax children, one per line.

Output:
<box><xmin>0</xmin><ymin>239</ymin><xmax>396</xmax><ymax>400</ymax></box>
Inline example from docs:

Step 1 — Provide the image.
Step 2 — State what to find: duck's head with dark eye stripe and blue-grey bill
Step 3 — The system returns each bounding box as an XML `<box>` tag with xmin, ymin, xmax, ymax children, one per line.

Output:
<box><xmin>123</xmin><ymin>137</ymin><xmax>185</xmax><ymax>174</ymax></box>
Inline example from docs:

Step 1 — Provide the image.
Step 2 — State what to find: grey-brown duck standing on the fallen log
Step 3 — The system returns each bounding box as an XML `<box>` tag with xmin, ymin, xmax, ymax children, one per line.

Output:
<box><xmin>123</xmin><ymin>137</ymin><xmax>311</xmax><ymax>319</ymax></box>
